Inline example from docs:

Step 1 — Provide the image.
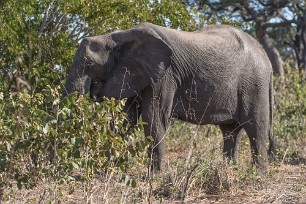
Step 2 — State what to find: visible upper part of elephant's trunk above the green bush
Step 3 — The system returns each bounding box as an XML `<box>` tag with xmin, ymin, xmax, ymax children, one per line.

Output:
<box><xmin>63</xmin><ymin>62</ymin><xmax>91</xmax><ymax>97</ymax></box>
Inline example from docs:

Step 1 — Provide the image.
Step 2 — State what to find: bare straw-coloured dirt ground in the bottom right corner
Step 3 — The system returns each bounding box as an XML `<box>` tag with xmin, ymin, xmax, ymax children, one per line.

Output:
<box><xmin>182</xmin><ymin>164</ymin><xmax>306</xmax><ymax>204</ymax></box>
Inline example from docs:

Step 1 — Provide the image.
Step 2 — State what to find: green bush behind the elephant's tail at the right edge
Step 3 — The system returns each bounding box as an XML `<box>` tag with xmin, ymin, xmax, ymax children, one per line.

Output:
<box><xmin>273</xmin><ymin>65</ymin><xmax>306</xmax><ymax>161</ymax></box>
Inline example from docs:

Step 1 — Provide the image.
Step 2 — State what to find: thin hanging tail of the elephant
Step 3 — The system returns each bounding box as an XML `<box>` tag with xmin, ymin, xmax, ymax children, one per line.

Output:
<box><xmin>268</xmin><ymin>73</ymin><xmax>276</xmax><ymax>161</ymax></box>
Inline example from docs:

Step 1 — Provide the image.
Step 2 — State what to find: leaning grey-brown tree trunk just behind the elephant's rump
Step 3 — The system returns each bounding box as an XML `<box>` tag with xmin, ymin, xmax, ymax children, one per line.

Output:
<box><xmin>255</xmin><ymin>21</ymin><xmax>284</xmax><ymax>78</ymax></box>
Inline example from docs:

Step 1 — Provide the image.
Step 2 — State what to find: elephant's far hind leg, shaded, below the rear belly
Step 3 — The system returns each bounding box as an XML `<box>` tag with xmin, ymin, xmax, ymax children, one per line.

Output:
<box><xmin>219</xmin><ymin>123</ymin><xmax>242</xmax><ymax>161</ymax></box>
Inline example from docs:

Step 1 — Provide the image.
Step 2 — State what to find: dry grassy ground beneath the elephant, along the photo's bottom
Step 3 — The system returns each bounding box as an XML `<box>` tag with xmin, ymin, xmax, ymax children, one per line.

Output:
<box><xmin>4</xmin><ymin>122</ymin><xmax>306</xmax><ymax>204</ymax></box>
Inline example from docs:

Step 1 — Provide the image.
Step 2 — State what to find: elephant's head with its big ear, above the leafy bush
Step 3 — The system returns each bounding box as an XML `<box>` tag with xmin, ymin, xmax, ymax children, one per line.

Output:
<box><xmin>63</xmin><ymin>26</ymin><xmax>172</xmax><ymax>101</ymax></box>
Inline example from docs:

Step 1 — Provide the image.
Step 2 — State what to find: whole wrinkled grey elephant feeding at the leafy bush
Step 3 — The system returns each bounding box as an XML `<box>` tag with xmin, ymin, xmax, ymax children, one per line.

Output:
<box><xmin>64</xmin><ymin>23</ymin><xmax>274</xmax><ymax>172</ymax></box>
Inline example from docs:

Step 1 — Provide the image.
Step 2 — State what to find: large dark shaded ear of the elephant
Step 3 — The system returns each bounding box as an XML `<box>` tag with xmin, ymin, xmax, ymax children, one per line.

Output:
<box><xmin>103</xmin><ymin>28</ymin><xmax>172</xmax><ymax>99</ymax></box>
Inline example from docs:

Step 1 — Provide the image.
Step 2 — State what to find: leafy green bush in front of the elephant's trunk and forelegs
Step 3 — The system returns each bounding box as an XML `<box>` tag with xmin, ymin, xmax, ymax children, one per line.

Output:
<box><xmin>0</xmin><ymin>87</ymin><xmax>149</xmax><ymax>202</ymax></box>
